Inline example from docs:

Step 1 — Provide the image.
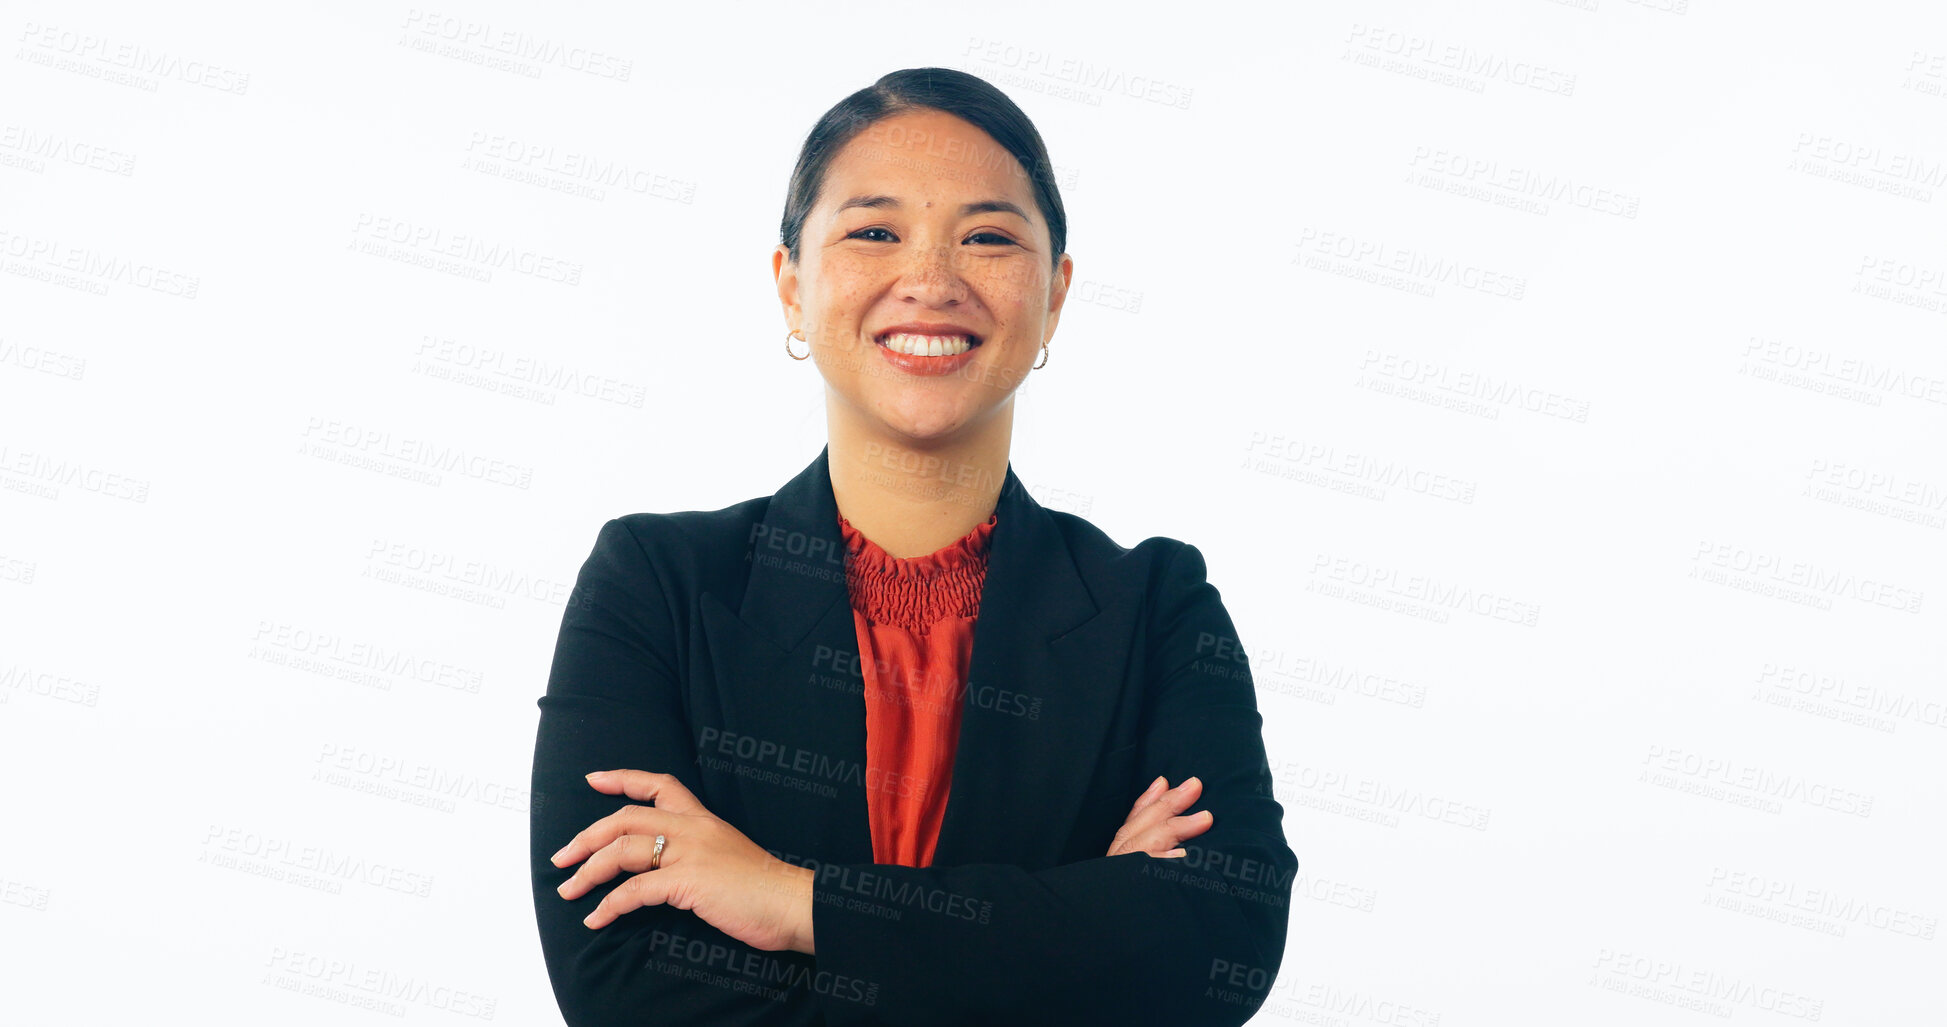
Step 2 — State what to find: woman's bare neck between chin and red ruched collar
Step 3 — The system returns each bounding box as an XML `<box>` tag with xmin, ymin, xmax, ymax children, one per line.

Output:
<box><xmin>826</xmin><ymin>398</ymin><xmax>1014</xmax><ymax>557</ymax></box>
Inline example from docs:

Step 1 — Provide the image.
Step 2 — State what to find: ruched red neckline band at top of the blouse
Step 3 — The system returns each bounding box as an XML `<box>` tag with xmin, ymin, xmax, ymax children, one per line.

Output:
<box><xmin>839</xmin><ymin>514</ymin><xmax>999</xmax><ymax>633</ymax></box>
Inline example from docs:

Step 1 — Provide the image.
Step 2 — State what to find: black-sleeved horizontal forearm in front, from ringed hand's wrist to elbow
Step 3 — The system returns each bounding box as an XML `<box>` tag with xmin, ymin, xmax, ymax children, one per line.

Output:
<box><xmin>814</xmin><ymin>830</ymin><xmax>1297</xmax><ymax>1025</ymax></box>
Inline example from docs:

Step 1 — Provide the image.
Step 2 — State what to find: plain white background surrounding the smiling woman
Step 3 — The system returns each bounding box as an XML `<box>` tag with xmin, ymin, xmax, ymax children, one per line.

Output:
<box><xmin>0</xmin><ymin>0</ymin><xmax>1947</xmax><ymax>1027</ymax></box>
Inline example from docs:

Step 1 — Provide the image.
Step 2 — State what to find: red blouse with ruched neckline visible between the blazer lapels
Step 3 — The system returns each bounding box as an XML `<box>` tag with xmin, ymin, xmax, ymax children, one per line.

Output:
<box><xmin>839</xmin><ymin>514</ymin><xmax>999</xmax><ymax>867</ymax></box>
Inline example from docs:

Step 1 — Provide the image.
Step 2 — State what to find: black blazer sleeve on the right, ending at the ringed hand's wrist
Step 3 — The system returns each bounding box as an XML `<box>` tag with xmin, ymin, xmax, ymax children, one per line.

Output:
<box><xmin>812</xmin><ymin>544</ymin><xmax>1299</xmax><ymax>1027</ymax></box>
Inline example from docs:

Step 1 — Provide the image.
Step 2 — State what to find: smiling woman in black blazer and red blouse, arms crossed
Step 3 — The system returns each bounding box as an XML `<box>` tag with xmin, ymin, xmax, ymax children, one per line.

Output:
<box><xmin>532</xmin><ymin>68</ymin><xmax>1297</xmax><ymax>1027</ymax></box>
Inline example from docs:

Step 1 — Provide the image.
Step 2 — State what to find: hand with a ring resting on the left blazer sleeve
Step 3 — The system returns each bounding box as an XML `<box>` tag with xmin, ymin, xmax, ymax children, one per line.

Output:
<box><xmin>553</xmin><ymin>770</ymin><xmax>814</xmax><ymax>953</ymax></box>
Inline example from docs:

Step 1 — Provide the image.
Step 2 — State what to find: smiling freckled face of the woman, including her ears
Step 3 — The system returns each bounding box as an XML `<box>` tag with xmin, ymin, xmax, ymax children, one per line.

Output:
<box><xmin>771</xmin><ymin>109</ymin><xmax>1073</xmax><ymax>442</ymax></box>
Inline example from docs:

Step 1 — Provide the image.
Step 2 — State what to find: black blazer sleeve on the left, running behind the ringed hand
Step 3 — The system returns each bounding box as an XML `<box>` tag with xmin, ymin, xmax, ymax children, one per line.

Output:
<box><xmin>528</xmin><ymin>520</ymin><xmax>814</xmax><ymax>1027</ymax></box>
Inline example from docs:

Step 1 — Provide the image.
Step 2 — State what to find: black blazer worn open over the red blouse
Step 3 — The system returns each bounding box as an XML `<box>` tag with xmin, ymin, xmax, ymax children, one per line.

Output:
<box><xmin>530</xmin><ymin>448</ymin><xmax>1299</xmax><ymax>1027</ymax></box>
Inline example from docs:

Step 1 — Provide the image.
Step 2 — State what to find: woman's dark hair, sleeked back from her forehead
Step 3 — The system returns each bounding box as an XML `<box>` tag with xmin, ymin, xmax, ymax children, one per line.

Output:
<box><xmin>779</xmin><ymin>68</ymin><xmax>1069</xmax><ymax>263</ymax></box>
